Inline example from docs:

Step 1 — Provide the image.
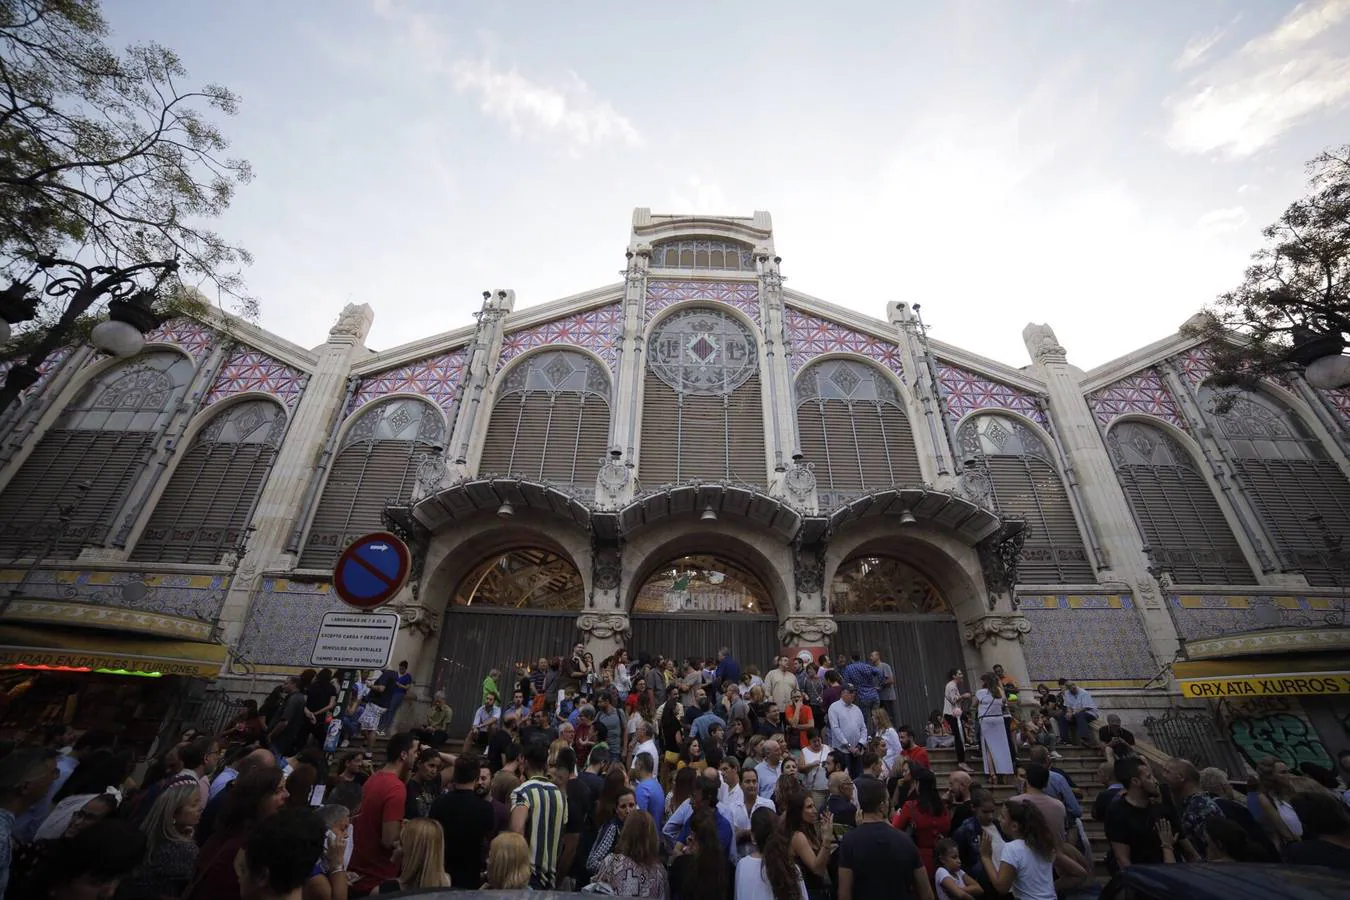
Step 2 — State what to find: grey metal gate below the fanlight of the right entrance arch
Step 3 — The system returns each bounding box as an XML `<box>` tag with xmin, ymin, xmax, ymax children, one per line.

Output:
<box><xmin>830</xmin><ymin>615</ymin><xmax>969</xmax><ymax>742</ymax></box>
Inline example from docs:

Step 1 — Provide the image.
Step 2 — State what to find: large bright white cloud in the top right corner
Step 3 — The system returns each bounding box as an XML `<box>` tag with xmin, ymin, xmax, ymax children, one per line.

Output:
<box><xmin>1165</xmin><ymin>0</ymin><xmax>1350</xmax><ymax>157</ymax></box>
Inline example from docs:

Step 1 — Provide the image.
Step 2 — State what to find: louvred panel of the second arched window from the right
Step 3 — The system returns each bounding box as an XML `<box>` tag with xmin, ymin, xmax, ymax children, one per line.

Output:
<box><xmin>1116</xmin><ymin>466</ymin><xmax>1254</xmax><ymax>584</ymax></box>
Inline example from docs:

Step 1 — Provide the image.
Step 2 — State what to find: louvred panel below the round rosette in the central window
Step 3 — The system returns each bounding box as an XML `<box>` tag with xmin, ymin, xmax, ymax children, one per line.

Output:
<box><xmin>639</xmin><ymin>370</ymin><xmax>765</xmax><ymax>487</ymax></box>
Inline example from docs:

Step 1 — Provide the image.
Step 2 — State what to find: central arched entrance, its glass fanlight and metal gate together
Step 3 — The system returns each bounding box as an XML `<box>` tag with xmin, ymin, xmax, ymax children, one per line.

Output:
<box><xmin>629</xmin><ymin>553</ymin><xmax>778</xmax><ymax>671</ymax></box>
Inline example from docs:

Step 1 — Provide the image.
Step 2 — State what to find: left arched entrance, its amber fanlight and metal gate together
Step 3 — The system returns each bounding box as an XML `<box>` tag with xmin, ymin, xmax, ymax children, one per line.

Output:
<box><xmin>436</xmin><ymin>546</ymin><xmax>586</xmax><ymax>733</ymax></box>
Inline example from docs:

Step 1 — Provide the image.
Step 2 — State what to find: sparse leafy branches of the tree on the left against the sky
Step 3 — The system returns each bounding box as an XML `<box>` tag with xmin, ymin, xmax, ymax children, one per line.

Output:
<box><xmin>0</xmin><ymin>0</ymin><xmax>257</xmax><ymax>318</ymax></box>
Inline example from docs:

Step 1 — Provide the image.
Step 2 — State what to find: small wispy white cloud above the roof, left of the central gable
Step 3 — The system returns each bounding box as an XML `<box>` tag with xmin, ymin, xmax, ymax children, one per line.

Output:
<box><xmin>452</xmin><ymin>59</ymin><xmax>643</xmax><ymax>150</ymax></box>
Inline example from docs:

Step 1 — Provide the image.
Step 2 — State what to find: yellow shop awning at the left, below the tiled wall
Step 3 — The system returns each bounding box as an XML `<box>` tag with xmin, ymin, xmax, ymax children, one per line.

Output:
<box><xmin>0</xmin><ymin>625</ymin><xmax>225</xmax><ymax>679</ymax></box>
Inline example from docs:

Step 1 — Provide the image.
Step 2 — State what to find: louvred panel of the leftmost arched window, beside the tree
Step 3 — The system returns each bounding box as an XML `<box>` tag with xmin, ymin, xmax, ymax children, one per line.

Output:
<box><xmin>0</xmin><ymin>429</ymin><xmax>157</xmax><ymax>559</ymax></box>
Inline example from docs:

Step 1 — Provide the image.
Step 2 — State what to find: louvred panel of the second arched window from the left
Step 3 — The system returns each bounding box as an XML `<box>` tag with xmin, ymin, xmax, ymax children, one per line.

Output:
<box><xmin>131</xmin><ymin>441</ymin><xmax>277</xmax><ymax>564</ymax></box>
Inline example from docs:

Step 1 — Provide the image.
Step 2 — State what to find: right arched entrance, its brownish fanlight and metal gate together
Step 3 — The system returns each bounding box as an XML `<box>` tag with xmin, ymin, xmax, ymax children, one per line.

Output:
<box><xmin>830</xmin><ymin>553</ymin><xmax>965</xmax><ymax>734</ymax></box>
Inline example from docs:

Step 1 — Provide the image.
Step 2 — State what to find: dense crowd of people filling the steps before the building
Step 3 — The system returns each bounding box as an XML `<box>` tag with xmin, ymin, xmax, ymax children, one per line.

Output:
<box><xmin>0</xmin><ymin>644</ymin><xmax>1350</xmax><ymax>900</ymax></box>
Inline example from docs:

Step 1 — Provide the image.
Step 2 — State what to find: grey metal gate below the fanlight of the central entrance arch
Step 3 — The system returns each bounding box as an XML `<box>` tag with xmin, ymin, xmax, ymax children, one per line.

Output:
<box><xmin>628</xmin><ymin>613</ymin><xmax>779</xmax><ymax>672</ymax></box>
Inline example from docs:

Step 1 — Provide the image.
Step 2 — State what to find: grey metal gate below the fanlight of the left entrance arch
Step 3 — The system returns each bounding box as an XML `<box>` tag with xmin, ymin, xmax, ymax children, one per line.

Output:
<box><xmin>434</xmin><ymin>609</ymin><xmax>578</xmax><ymax>735</ymax></box>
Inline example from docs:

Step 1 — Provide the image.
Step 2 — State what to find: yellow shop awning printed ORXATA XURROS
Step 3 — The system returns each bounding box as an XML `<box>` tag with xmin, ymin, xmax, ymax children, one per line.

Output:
<box><xmin>1172</xmin><ymin>653</ymin><xmax>1350</xmax><ymax>700</ymax></box>
